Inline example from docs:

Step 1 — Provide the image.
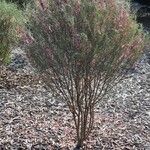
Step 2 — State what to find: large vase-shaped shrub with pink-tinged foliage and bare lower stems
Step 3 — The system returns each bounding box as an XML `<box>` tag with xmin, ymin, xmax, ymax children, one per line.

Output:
<box><xmin>27</xmin><ymin>0</ymin><xmax>144</xmax><ymax>148</ymax></box>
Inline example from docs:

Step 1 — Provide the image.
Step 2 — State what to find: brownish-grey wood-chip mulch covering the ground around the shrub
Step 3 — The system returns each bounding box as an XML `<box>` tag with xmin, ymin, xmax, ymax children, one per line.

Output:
<box><xmin>0</xmin><ymin>46</ymin><xmax>150</xmax><ymax>150</ymax></box>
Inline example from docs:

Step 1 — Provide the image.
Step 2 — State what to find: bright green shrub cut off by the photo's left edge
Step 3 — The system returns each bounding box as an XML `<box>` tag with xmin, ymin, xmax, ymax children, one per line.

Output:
<box><xmin>0</xmin><ymin>1</ymin><xmax>24</xmax><ymax>62</ymax></box>
